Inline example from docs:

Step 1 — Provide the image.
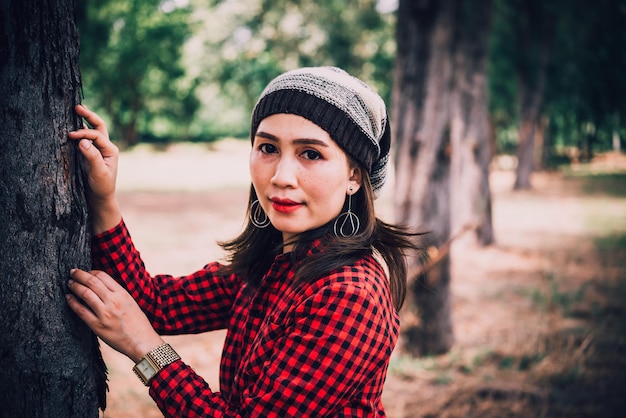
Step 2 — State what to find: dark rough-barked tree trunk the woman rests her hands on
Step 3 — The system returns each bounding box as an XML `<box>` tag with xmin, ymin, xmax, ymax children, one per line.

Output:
<box><xmin>0</xmin><ymin>0</ymin><xmax>106</xmax><ymax>417</ymax></box>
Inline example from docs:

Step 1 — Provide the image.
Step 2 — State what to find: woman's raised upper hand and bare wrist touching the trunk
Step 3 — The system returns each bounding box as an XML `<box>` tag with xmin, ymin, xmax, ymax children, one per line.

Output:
<box><xmin>68</xmin><ymin>105</ymin><xmax>122</xmax><ymax>234</ymax></box>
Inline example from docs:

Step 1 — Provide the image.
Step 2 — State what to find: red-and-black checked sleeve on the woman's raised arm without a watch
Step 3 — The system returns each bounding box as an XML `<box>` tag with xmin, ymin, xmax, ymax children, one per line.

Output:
<box><xmin>92</xmin><ymin>221</ymin><xmax>240</xmax><ymax>335</ymax></box>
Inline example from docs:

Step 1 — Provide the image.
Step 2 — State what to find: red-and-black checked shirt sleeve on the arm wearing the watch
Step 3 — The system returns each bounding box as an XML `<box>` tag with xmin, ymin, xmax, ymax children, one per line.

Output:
<box><xmin>150</xmin><ymin>276</ymin><xmax>397</xmax><ymax>418</ymax></box>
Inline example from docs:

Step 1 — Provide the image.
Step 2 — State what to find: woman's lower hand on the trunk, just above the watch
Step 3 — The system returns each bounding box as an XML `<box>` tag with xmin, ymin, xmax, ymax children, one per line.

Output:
<box><xmin>67</xmin><ymin>269</ymin><xmax>163</xmax><ymax>363</ymax></box>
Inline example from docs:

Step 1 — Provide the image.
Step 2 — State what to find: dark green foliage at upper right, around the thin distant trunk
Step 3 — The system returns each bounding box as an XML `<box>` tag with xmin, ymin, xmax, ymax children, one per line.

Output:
<box><xmin>489</xmin><ymin>0</ymin><xmax>626</xmax><ymax>161</ymax></box>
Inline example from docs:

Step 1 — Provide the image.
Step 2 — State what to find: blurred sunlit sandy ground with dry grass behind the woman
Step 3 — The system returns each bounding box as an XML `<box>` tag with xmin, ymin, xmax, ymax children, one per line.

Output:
<box><xmin>97</xmin><ymin>141</ymin><xmax>626</xmax><ymax>418</ymax></box>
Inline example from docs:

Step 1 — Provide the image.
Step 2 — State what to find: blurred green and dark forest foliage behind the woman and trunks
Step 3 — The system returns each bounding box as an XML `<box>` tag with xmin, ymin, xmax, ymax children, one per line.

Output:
<box><xmin>77</xmin><ymin>0</ymin><xmax>626</xmax><ymax>160</ymax></box>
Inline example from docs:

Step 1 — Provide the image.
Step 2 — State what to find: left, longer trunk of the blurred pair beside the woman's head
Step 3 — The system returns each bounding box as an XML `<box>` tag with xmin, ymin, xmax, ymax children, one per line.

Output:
<box><xmin>391</xmin><ymin>0</ymin><xmax>455</xmax><ymax>355</ymax></box>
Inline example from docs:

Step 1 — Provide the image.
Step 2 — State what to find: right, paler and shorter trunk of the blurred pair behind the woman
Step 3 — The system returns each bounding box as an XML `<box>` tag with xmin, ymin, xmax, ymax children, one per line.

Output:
<box><xmin>451</xmin><ymin>0</ymin><xmax>495</xmax><ymax>245</ymax></box>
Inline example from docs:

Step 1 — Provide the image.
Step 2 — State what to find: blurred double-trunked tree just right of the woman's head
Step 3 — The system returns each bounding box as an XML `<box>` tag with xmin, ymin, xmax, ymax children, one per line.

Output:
<box><xmin>391</xmin><ymin>0</ymin><xmax>493</xmax><ymax>355</ymax></box>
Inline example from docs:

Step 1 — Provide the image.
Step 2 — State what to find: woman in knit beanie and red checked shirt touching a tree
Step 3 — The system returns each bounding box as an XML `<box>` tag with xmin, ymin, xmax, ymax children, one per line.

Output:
<box><xmin>68</xmin><ymin>67</ymin><xmax>415</xmax><ymax>418</ymax></box>
